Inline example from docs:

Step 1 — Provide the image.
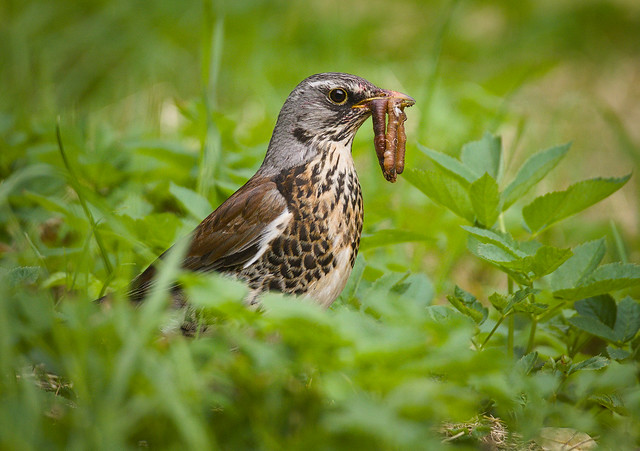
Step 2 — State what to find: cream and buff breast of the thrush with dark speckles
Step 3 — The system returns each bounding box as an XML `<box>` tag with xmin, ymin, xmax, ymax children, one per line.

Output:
<box><xmin>246</xmin><ymin>146</ymin><xmax>363</xmax><ymax>306</ymax></box>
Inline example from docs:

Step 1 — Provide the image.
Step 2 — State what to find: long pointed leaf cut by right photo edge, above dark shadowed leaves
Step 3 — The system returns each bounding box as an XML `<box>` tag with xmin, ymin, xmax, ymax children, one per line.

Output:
<box><xmin>553</xmin><ymin>263</ymin><xmax>640</xmax><ymax>300</ymax></box>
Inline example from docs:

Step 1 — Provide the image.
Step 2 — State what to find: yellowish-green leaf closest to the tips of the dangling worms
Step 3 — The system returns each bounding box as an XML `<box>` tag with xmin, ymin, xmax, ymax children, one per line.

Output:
<box><xmin>404</xmin><ymin>169</ymin><xmax>475</xmax><ymax>222</ymax></box>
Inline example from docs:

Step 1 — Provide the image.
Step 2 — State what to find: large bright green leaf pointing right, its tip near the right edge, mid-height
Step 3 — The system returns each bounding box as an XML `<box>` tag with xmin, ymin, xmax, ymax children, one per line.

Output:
<box><xmin>522</xmin><ymin>174</ymin><xmax>631</xmax><ymax>233</ymax></box>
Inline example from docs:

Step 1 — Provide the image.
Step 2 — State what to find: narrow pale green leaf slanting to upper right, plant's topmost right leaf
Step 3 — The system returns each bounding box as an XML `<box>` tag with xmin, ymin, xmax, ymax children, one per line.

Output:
<box><xmin>502</xmin><ymin>143</ymin><xmax>571</xmax><ymax>210</ymax></box>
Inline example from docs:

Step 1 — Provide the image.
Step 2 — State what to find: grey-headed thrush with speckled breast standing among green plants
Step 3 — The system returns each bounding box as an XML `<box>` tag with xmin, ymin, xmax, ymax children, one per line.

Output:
<box><xmin>128</xmin><ymin>72</ymin><xmax>415</xmax><ymax>314</ymax></box>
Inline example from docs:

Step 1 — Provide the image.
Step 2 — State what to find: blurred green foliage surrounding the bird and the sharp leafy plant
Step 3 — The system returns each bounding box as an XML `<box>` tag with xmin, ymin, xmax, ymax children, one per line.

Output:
<box><xmin>0</xmin><ymin>0</ymin><xmax>640</xmax><ymax>449</ymax></box>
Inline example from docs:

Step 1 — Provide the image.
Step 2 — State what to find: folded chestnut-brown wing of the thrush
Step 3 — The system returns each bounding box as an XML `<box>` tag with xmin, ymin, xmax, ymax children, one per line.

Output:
<box><xmin>129</xmin><ymin>176</ymin><xmax>287</xmax><ymax>301</ymax></box>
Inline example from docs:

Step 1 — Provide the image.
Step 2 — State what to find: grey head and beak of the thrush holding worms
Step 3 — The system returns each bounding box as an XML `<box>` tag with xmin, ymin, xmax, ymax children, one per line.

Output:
<box><xmin>262</xmin><ymin>72</ymin><xmax>415</xmax><ymax>174</ymax></box>
